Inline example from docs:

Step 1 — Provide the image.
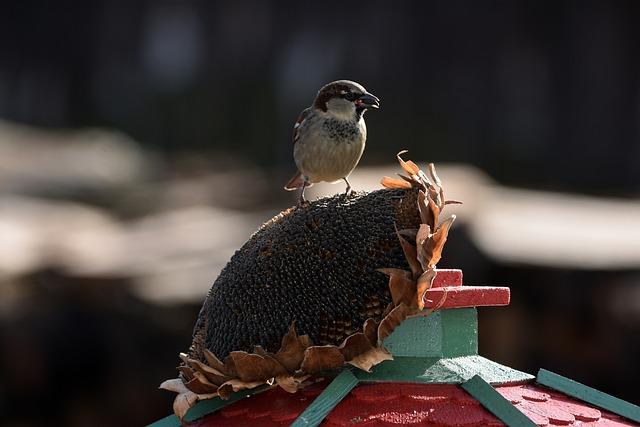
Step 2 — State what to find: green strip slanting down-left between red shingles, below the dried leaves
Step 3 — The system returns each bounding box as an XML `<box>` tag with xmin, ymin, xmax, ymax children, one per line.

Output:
<box><xmin>291</xmin><ymin>369</ymin><xmax>358</xmax><ymax>427</ymax></box>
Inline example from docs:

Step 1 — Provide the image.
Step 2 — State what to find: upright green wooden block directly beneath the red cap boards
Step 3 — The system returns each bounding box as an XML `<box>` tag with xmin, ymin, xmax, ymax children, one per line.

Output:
<box><xmin>384</xmin><ymin>308</ymin><xmax>478</xmax><ymax>357</ymax></box>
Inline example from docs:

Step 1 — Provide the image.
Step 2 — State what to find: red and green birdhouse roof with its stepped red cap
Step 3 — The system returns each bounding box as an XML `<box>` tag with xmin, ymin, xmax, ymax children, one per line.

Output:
<box><xmin>153</xmin><ymin>270</ymin><xmax>640</xmax><ymax>427</ymax></box>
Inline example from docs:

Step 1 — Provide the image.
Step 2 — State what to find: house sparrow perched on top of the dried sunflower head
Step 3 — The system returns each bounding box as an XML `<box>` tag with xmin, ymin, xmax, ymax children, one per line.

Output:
<box><xmin>284</xmin><ymin>80</ymin><xmax>380</xmax><ymax>204</ymax></box>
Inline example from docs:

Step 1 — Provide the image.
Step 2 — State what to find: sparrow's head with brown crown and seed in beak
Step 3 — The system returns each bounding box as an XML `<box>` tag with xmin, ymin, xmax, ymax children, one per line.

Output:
<box><xmin>313</xmin><ymin>80</ymin><xmax>380</xmax><ymax>120</ymax></box>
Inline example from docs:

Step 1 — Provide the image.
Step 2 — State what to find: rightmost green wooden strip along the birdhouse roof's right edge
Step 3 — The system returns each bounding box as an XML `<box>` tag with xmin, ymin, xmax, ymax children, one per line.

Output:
<box><xmin>536</xmin><ymin>369</ymin><xmax>640</xmax><ymax>423</ymax></box>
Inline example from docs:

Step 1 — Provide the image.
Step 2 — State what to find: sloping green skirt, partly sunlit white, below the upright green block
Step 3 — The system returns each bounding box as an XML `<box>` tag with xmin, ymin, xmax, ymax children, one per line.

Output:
<box><xmin>355</xmin><ymin>355</ymin><xmax>535</xmax><ymax>384</ymax></box>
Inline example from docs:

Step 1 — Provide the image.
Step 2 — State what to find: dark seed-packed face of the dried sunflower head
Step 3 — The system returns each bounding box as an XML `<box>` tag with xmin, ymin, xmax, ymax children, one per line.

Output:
<box><xmin>190</xmin><ymin>189</ymin><xmax>420</xmax><ymax>359</ymax></box>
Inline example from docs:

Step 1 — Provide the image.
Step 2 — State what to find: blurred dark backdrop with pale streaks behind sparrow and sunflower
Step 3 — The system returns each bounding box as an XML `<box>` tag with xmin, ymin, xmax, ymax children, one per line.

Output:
<box><xmin>0</xmin><ymin>0</ymin><xmax>640</xmax><ymax>426</ymax></box>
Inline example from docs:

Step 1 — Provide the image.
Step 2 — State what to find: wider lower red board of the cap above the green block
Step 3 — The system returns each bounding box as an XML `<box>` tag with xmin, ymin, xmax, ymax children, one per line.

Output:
<box><xmin>423</xmin><ymin>286</ymin><xmax>511</xmax><ymax>308</ymax></box>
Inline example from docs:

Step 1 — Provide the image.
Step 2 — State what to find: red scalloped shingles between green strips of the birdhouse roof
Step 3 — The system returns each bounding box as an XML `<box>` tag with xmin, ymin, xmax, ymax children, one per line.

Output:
<box><xmin>188</xmin><ymin>380</ymin><xmax>636</xmax><ymax>427</ymax></box>
